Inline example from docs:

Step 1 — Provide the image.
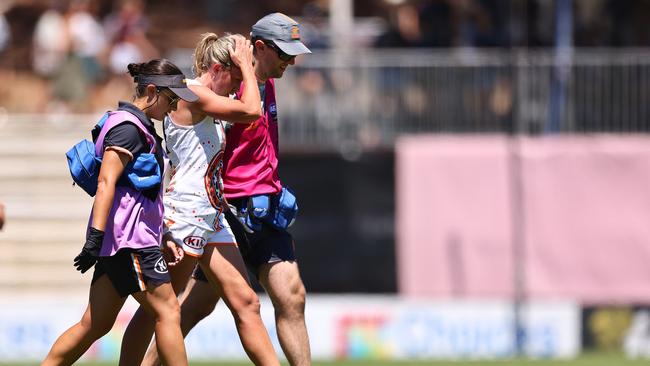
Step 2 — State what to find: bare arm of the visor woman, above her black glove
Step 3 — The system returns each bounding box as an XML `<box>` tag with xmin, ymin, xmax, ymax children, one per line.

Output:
<box><xmin>92</xmin><ymin>149</ymin><xmax>130</xmax><ymax>231</ymax></box>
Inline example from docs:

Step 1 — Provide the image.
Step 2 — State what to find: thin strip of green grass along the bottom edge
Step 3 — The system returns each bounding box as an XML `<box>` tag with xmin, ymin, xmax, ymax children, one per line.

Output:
<box><xmin>0</xmin><ymin>353</ymin><xmax>650</xmax><ymax>366</ymax></box>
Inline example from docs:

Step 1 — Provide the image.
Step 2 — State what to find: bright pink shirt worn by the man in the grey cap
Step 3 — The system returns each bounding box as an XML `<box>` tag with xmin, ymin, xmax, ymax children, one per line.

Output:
<box><xmin>223</xmin><ymin>79</ymin><xmax>282</xmax><ymax>198</ymax></box>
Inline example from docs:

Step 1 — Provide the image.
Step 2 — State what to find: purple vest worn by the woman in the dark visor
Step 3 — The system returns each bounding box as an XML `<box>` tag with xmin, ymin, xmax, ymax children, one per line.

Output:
<box><xmin>88</xmin><ymin>111</ymin><xmax>163</xmax><ymax>257</ymax></box>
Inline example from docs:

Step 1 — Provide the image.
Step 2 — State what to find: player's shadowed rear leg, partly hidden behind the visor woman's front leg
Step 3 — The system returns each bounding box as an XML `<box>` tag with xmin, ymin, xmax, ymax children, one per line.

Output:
<box><xmin>120</xmin><ymin>242</ymin><xmax>196</xmax><ymax>365</ymax></box>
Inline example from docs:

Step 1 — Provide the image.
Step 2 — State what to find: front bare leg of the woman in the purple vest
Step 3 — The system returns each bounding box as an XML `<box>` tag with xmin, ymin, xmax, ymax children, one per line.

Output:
<box><xmin>129</xmin><ymin>283</ymin><xmax>187</xmax><ymax>366</ymax></box>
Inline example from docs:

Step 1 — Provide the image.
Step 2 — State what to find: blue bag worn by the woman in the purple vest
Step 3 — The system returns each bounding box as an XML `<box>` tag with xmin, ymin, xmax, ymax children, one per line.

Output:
<box><xmin>65</xmin><ymin>111</ymin><xmax>162</xmax><ymax>197</ymax></box>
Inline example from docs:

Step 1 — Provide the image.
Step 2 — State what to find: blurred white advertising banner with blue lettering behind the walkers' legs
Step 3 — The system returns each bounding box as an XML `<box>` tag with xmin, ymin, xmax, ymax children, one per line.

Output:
<box><xmin>0</xmin><ymin>296</ymin><xmax>580</xmax><ymax>361</ymax></box>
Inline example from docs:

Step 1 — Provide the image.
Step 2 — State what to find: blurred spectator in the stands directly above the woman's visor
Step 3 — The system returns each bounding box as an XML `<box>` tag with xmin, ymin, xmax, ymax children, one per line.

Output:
<box><xmin>104</xmin><ymin>0</ymin><xmax>159</xmax><ymax>74</ymax></box>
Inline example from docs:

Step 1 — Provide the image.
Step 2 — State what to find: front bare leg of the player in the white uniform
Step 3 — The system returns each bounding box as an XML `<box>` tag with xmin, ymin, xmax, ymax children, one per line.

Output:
<box><xmin>199</xmin><ymin>246</ymin><xmax>280</xmax><ymax>365</ymax></box>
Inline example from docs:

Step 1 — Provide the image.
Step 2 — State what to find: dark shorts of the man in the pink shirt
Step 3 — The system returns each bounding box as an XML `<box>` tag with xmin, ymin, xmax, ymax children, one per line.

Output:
<box><xmin>193</xmin><ymin>202</ymin><xmax>296</xmax><ymax>282</ymax></box>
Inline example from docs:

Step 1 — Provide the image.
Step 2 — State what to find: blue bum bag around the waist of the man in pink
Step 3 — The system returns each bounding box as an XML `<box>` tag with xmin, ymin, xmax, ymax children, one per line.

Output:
<box><xmin>238</xmin><ymin>187</ymin><xmax>298</xmax><ymax>232</ymax></box>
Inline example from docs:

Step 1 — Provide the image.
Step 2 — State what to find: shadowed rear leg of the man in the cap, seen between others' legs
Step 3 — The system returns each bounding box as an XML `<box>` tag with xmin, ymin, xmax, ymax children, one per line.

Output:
<box><xmin>141</xmin><ymin>278</ymin><xmax>219</xmax><ymax>366</ymax></box>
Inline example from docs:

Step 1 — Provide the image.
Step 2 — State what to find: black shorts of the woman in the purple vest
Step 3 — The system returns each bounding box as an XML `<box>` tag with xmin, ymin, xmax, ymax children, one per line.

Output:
<box><xmin>92</xmin><ymin>247</ymin><xmax>171</xmax><ymax>297</ymax></box>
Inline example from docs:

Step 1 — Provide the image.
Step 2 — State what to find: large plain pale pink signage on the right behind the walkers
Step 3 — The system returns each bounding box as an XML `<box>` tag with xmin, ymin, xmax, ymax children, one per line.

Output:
<box><xmin>396</xmin><ymin>135</ymin><xmax>650</xmax><ymax>303</ymax></box>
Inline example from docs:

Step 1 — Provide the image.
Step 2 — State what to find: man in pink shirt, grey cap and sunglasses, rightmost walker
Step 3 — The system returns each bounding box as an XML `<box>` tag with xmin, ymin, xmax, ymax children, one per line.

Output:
<box><xmin>171</xmin><ymin>13</ymin><xmax>311</xmax><ymax>366</ymax></box>
